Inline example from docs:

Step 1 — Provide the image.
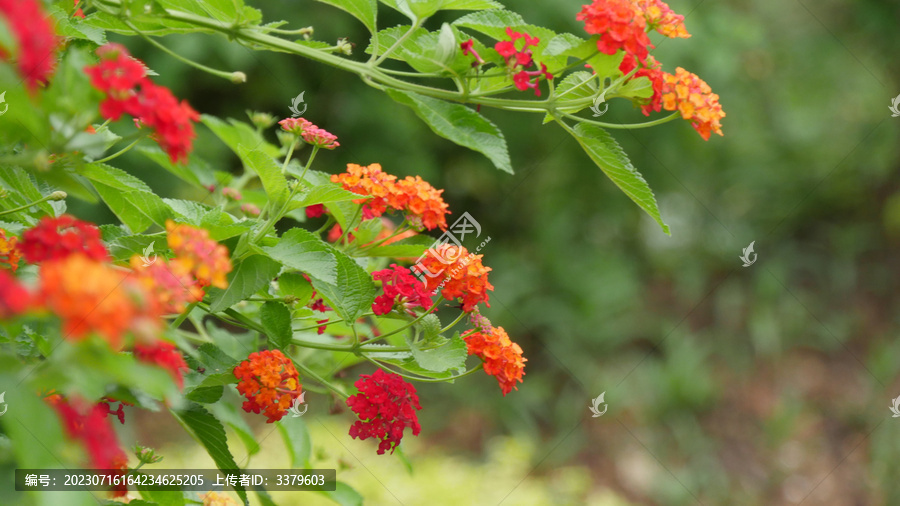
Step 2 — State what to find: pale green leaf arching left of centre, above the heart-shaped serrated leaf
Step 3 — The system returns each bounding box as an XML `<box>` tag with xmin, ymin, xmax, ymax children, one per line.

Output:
<box><xmin>263</xmin><ymin>228</ymin><xmax>337</xmax><ymax>284</ymax></box>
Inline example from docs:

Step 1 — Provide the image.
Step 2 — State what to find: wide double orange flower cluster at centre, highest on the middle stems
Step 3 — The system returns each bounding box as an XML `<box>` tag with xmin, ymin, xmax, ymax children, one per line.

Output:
<box><xmin>331</xmin><ymin>163</ymin><xmax>450</xmax><ymax>230</ymax></box>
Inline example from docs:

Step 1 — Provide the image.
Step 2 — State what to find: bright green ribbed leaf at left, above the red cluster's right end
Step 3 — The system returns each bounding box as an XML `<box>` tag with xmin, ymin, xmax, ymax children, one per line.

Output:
<box><xmin>82</xmin><ymin>163</ymin><xmax>173</xmax><ymax>232</ymax></box>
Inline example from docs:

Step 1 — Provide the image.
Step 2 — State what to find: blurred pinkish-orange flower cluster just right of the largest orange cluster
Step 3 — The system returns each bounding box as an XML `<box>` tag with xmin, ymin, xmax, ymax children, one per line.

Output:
<box><xmin>131</xmin><ymin>255</ymin><xmax>205</xmax><ymax>314</ymax></box>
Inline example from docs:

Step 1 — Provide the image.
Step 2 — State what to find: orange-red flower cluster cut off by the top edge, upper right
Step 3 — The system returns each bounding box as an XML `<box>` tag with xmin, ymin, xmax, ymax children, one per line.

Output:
<box><xmin>575</xmin><ymin>0</ymin><xmax>654</xmax><ymax>61</ymax></box>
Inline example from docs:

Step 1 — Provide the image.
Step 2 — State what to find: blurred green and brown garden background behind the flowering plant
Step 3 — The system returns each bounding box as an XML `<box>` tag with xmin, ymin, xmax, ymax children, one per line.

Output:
<box><xmin>70</xmin><ymin>0</ymin><xmax>900</xmax><ymax>505</ymax></box>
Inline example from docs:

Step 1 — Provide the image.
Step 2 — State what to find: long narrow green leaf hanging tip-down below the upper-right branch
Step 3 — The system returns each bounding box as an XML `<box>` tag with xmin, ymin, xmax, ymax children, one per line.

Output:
<box><xmin>574</xmin><ymin>123</ymin><xmax>669</xmax><ymax>234</ymax></box>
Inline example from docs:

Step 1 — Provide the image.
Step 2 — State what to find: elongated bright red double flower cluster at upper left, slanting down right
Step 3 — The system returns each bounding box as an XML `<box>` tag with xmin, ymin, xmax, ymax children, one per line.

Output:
<box><xmin>84</xmin><ymin>43</ymin><xmax>200</xmax><ymax>163</ymax></box>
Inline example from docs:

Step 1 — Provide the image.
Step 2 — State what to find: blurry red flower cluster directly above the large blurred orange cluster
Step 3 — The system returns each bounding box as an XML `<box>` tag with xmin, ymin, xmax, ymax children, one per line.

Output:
<box><xmin>19</xmin><ymin>214</ymin><xmax>109</xmax><ymax>264</ymax></box>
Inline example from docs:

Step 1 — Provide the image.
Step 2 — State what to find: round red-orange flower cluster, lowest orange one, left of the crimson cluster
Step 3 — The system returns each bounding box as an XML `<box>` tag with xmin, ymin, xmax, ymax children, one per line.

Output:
<box><xmin>234</xmin><ymin>350</ymin><xmax>303</xmax><ymax>423</ymax></box>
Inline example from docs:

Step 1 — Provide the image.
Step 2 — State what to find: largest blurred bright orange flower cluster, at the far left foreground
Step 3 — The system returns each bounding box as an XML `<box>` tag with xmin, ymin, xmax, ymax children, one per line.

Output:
<box><xmin>36</xmin><ymin>253</ymin><xmax>159</xmax><ymax>348</ymax></box>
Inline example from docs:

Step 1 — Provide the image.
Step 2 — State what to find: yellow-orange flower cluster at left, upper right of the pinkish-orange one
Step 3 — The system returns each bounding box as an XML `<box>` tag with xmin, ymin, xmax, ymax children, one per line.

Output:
<box><xmin>166</xmin><ymin>220</ymin><xmax>232</xmax><ymax>289</ymax></box>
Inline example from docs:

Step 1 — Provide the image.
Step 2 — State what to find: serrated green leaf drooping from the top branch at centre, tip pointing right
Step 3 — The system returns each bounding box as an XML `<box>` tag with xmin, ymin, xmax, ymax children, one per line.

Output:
<box><xmin>387</xmin><ymin>88</ymin><xmax>513</xmax><ymax>174</ymax></box>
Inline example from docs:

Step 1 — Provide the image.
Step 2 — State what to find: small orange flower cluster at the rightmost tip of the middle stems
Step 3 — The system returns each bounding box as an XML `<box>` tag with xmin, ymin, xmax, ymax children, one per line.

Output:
<box><xmin>464</xmin><ymin>327</ymin><xmax>528</xmax><ymax>396</ymax></box>
